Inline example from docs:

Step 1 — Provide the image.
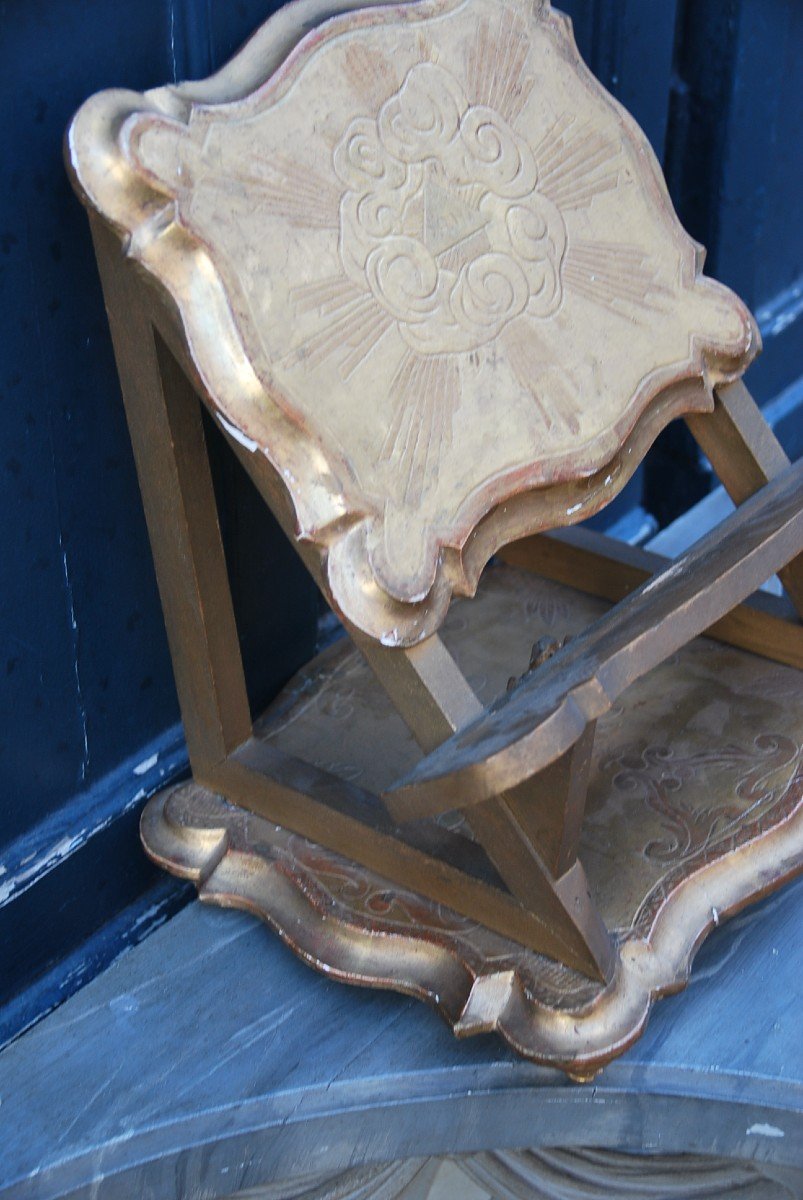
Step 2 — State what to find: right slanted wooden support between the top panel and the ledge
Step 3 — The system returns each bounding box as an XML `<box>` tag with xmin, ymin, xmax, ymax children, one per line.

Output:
<box><xmin>685</xmin><ymin>379</ymin><xmax>803</xmax><ymax>616</ymax></box>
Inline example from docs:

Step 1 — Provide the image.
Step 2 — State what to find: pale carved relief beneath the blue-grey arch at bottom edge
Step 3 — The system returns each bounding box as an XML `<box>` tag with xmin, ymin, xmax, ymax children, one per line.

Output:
<box><xmin>226</xmin><ymin>1150</ymin><xmax>803</xmax><ymax>1200</ymax></box>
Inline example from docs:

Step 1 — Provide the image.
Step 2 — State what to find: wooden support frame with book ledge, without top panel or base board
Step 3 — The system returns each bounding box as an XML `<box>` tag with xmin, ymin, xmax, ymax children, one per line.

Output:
<box><xmin>92</xmin><ymin>216</ymin><xmax>803</xmax><ymax>980</ymax></box>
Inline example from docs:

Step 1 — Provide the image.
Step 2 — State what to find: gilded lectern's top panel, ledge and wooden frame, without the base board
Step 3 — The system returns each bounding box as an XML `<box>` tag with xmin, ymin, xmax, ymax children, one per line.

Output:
<box><xmin>67</xmin><ymin>0</ymin><xmax>803</xmax><ymax>1008</ymax></box>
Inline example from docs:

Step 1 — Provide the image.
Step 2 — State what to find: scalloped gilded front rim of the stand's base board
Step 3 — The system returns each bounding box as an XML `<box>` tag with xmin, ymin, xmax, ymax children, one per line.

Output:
<box><xmin>140</xmin><ymin>782</ymin><xmax>803</xmax><ymax>1081</ymax></box>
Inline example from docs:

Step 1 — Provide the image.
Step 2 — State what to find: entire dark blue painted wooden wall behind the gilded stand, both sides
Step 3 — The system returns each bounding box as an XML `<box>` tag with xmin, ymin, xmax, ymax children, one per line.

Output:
<box><xmin>0</xmin><ymin>0</ymin><xmax>803</xmax><ymax>1042</ymax></box>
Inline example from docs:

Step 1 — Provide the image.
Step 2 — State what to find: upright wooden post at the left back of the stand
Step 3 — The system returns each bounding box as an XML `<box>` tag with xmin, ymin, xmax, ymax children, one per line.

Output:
<box><xmin>92</xmin><ymin>221</ymin><xmax>251</xmax><ymax>772</ymax></box>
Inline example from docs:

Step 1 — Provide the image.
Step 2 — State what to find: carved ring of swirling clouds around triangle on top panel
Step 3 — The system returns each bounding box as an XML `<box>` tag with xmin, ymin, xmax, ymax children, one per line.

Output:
<box><xmin>334</xmin><ymin>62</ymin><xmax>567</xmax><ymax>358</ymax></box>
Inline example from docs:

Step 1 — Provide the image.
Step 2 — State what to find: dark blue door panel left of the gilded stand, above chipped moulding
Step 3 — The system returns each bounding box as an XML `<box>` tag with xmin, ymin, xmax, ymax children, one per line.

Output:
<box><xmin>0</xmin><ymin>0</ymin><xmax>184</xmax><ymax>841</ymax></box>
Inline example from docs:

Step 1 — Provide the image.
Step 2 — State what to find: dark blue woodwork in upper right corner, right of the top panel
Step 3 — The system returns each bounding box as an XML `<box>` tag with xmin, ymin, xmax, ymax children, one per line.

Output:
<box><xmin>667</xmin><ymin>0</ymin><xmax>803</xmax><ymax>401</ymax></box>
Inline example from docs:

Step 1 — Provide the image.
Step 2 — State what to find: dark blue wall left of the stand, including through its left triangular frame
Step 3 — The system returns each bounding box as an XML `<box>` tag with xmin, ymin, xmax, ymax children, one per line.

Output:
<box><xmin>0</xmin><ymin>0</ymin><xmax>317</xmax><ymax>1022</ymax></box>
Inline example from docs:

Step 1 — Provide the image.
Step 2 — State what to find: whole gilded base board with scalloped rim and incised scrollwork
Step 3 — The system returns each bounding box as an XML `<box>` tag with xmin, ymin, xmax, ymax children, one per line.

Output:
<box><xmin>142</xmin><ymin>568</ymin><xmax>803</xmax><ymax>1075</ymax></box>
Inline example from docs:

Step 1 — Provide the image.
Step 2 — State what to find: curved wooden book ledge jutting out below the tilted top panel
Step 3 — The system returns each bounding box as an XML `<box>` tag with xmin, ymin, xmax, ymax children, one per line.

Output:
<box><xmin>386</xmin><ymin>461</ymin><xmax>803</xmax><ymax>821</ymax></box>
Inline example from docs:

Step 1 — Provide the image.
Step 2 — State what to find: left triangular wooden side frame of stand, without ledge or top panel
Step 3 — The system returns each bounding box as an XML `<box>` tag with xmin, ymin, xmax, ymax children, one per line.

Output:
<box><xmin>92</xmin><ymin>221</ymin><xmax>613</xmax><ymax>978</ymax></box>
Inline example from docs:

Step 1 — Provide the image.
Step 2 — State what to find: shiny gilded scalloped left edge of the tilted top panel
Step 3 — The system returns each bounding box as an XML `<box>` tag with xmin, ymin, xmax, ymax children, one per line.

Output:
<box><xmin>65</xmin><ymin>89</ymin><xmax>359</xmax><ymax>545</ymax></box>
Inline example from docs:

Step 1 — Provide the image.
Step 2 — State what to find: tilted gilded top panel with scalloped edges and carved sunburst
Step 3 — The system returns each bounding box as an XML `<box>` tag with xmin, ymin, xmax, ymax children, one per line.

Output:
<box><xmin>70</xmin><ymin>0</ymin><xmax>757</xmax><ymax>644</ymax></box>
